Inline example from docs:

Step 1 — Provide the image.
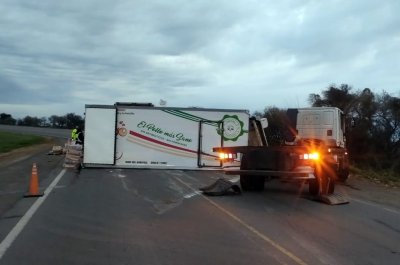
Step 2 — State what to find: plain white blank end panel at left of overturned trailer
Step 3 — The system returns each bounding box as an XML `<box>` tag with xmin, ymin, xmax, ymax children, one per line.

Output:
<box><xmin>83</xmin><ymin>106</ymin><xmax>116</xmax><ymax>165</ymax></box>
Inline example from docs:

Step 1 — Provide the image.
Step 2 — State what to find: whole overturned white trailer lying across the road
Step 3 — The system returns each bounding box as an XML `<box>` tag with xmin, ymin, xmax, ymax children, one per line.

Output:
<box><xmin>83</xmin><ymin>103</ymin><xmax>249</xmax><ymax>169</ymax></box>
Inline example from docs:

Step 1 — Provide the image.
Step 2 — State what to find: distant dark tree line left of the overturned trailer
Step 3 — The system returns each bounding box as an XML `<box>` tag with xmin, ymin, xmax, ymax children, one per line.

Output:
<box><xmin>0</xmin><ymin>113</ymin><xmax>84</xmax><ymax>129</ymax></box>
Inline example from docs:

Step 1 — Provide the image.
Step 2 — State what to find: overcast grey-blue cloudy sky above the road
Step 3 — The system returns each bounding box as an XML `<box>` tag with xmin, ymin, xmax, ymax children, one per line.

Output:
<box><xmin>0</xmin><ymin>0</ymin><xmax>400</xmax><ymax>118</ymax></box>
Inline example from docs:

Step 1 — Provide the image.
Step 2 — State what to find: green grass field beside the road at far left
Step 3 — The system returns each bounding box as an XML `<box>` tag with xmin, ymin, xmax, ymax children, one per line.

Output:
<box><xmin>0</xmin><ymin>132</ymin><xmax>47</xmax><ymax>153</ymax></box>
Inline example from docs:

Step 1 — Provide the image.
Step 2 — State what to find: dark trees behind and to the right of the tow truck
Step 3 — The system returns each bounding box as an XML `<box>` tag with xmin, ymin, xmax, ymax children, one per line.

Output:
<box><xmin>255</xmin><ymin>84</ymin><xmax>400</xmax><ymax>173</ymax></box>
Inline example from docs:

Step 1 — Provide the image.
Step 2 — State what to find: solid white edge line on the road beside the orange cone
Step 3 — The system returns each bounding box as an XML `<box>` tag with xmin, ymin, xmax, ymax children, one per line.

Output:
<box><xmin>0</xmin><ymin>168</ymin><xmax>66</xmax><ymax>260</ymax></box>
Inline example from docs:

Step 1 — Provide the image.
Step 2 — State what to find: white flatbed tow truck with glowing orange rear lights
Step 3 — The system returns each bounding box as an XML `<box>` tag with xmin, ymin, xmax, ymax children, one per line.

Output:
<box><xmin>213</xmin><ymin>107</ymin><xmax>349</xmax><ymax>201</ymax></box>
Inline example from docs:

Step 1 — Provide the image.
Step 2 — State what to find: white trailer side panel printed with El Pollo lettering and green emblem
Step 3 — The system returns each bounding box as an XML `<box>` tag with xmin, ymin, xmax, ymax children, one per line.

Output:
<box><xmin>116</xmin><ymin>107</ymin><xmax>249</xmax><ymax>169</ymax></box>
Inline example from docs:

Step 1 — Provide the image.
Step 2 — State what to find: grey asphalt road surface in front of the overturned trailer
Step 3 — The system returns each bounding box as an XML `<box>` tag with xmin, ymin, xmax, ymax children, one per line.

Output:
<box><xmin>0</xmin><ymin>127</ymin><xmax>400</xmax><ymax>265</ymax></box>
